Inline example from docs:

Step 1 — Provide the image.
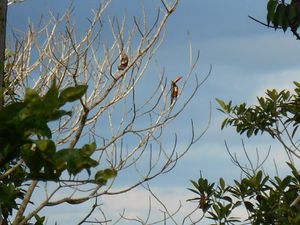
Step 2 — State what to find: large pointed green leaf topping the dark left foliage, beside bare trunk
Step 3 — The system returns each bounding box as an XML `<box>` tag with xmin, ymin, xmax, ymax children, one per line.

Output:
<box><xmin>59</xmin><ymin>85</ymin><xmax>88</xmax><ymax>106</ymax></box>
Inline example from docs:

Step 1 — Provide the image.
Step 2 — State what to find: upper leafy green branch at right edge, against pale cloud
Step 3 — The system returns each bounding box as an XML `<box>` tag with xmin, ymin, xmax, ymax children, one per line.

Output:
<box><xmin>217</xmin><ymin>82</ymin><xmax>300</xmax><ymax>138</ymax></box>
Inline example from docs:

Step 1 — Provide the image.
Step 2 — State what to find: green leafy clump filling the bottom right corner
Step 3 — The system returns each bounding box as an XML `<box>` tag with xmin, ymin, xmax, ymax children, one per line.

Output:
<box><xmin>189</xmin><ymin>164</ymin><xmax>300</xmax><ymax>224</ymax></box>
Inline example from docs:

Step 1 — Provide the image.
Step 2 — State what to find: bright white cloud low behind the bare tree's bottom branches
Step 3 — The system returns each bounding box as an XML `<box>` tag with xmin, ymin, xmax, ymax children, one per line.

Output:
<box><xmin>103</xmin><ymin>186</ymin><xmax>201</xmax><ymax>224</ymax></box>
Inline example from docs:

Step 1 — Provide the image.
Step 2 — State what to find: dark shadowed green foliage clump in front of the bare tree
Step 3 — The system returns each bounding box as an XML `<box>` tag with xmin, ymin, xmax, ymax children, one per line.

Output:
<box><xmin>0</xmin><ymin>82</ymin><xmax>97</xmax><ymax>176</ymax></box>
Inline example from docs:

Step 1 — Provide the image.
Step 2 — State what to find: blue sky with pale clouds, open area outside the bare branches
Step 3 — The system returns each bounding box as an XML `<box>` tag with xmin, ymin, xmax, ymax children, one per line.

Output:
<box><xmin>8</xmin><ymin>0</ymin><xmax>300</xmax><ymax>224</ymax></box>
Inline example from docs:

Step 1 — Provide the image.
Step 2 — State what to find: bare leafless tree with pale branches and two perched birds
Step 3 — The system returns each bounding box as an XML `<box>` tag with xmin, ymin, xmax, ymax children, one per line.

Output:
<box><xmin>1</xmin><ymin>0</ymin><xmax>209</xmax><ymax>225</ymax></box>
